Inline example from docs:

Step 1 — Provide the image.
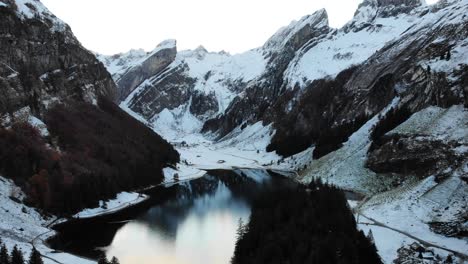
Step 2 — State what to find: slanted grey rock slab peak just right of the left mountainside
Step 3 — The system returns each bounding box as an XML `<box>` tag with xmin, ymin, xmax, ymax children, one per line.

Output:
<box><xmin>117</xmin><ymin>43</ymin><xmax>177</xmax><ymax>100</ymax></box>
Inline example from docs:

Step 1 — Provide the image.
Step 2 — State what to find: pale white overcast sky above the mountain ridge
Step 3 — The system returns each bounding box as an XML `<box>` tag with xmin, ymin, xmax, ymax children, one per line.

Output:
<box><xmin>42</xmin><ymin>0</ymin><xmax>436</xmax><ymax>54</ymax></box>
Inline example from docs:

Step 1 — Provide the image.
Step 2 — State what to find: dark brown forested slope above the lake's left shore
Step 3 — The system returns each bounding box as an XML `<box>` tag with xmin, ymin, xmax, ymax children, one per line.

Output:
<box><xmin>0</xmin><ymin>100</ymin><xmax>179</xmax><ymax>213</ymax></box>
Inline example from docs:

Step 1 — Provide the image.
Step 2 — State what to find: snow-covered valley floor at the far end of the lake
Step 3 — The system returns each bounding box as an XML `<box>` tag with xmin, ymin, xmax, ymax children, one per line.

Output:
<box><xmin>120</xmin><ymin>103</ymin><xmax>293</xmax><ymax>174</ymax></box>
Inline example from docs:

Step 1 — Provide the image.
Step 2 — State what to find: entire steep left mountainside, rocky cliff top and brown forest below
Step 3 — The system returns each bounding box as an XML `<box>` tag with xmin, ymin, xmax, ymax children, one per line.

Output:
<box><xmin>0</xmin><ymin>0</ymin><xmax>179</xmax><ymax>214</ymax></box>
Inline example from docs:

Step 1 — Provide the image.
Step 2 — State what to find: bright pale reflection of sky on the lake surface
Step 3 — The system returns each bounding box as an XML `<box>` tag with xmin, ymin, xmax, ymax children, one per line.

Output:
<box><xmin>107</xmin><ymin>186</ymin><xmax>250</xmax><ymax>264</ymax></box>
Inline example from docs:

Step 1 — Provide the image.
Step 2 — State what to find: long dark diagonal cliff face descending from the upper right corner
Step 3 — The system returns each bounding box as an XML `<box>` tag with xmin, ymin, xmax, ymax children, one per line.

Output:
<box><xmin>266</xmin><ymin>2</ymin><xmax>468</xmax><ymax>154</ymax></box>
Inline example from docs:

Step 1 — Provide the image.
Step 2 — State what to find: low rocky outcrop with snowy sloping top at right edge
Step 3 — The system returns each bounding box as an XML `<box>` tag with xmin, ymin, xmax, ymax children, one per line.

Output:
<box><xmin>367</xmin><ymin>105</ymin><xmax>468</xmax><ymax>180</ymax></box>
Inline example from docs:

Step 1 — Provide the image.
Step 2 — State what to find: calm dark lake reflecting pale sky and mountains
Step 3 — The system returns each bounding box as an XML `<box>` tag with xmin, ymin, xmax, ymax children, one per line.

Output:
<box><xmin>49</xmin><ymin>170</ymin><xmax>296</xmax><ymax>264</ymax></box>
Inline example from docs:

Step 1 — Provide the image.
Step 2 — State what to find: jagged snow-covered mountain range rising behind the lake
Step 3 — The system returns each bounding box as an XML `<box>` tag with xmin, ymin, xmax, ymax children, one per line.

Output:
<box><xmin>99</xmin><ymin>0</ymin><xmax>467</xmax><ymax>151</ymax></box>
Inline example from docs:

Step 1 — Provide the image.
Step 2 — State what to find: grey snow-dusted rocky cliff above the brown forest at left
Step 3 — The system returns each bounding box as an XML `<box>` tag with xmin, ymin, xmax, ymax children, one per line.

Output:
<box><xmin>0</xmin><ymin>0</ymin><xmax>116</xmax><ymax>115</ymax></box>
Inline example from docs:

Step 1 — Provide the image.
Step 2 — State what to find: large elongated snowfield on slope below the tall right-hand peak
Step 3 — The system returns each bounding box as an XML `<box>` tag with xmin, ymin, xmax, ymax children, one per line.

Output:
<box><xmin>284</xmin><ymin>15</ymin><xmax>414</xmax><ymax>87</ymax></box>
